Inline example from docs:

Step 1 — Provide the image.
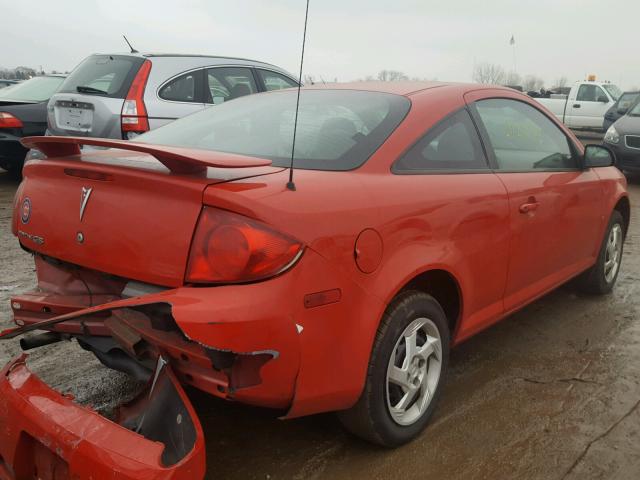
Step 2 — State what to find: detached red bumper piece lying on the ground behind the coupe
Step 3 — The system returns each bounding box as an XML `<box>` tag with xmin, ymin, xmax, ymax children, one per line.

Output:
<box><xmin>0</xmin><ymin>355</ymin><xmax>205</xmax><ymax>480</ymax></box>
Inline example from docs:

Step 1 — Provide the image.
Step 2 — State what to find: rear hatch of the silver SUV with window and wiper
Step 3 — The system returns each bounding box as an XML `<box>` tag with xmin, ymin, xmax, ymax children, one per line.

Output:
<box><xmin>47</xmin><ymin>55</ymin><xmax>151</xmax><ymax>139</ymax></box>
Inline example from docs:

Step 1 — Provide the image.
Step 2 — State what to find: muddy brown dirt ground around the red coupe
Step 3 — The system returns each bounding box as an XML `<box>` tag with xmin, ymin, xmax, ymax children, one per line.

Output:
<box><xmin>0</xmin><ymin>166</ymin><xmax>640</xmax><ymax>480</ymax></box>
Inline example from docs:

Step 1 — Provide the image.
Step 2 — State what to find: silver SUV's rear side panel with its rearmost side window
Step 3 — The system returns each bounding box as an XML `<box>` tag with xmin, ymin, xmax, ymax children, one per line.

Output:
<box><xmin>148</xmin><ymin>69</ymin><xmax>205</xmax><ymax>130</ymax></box>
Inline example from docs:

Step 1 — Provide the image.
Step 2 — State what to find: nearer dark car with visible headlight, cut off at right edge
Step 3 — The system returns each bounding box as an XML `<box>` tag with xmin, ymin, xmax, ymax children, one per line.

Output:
<box><xmin>604</xmin><ymin>103</ymin><xmax>640</xmax><ymax>172</ymax></box>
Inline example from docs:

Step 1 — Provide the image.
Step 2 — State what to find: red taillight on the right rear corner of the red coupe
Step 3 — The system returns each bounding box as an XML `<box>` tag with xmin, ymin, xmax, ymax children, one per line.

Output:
<box><xmin>186</xmin><ymin>207</ymin><xmax>302</xmax><ymax>283</ymax></box>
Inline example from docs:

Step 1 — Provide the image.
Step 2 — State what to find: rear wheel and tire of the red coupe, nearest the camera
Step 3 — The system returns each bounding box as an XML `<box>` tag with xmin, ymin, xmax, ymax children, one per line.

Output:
<box><xmin>338</xmin><ymin>291</ymin><xmax>450</xmax><ymax>447</ymax></box>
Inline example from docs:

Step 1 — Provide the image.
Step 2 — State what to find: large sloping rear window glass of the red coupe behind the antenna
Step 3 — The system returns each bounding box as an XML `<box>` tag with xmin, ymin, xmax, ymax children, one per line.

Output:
<box><xmin>136</xmin><ymin>90</ymin><xmax>411</xmax><ymax>170</ymax></box>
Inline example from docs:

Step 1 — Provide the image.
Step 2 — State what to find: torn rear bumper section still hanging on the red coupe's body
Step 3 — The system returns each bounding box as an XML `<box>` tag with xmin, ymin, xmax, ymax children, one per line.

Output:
<box><xmin>6</xmin><ymin>278</ymin><xmax>300</xmax><ymax>410</ymax></box>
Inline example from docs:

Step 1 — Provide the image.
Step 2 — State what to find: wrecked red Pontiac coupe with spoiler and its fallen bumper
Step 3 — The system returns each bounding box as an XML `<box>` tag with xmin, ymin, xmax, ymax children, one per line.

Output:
<box><xmin>0</xmin><ymin>83</ymin><xmax>629</xmax><ymax>478</ymax></box>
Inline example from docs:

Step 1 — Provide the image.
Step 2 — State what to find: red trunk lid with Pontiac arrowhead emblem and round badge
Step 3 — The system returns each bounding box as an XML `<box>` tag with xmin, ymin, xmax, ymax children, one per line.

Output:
<box><xmin>14</xmin><ymin>141</ymin><xmax>282</xmax><ymax>287</ymax></box>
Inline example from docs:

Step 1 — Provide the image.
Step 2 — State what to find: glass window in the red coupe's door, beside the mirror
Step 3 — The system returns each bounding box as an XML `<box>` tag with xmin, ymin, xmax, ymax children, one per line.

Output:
<box><xmin>475</xmin><ymin>99</ymin><xmax>578</xmax><ymax>171</ymax></box>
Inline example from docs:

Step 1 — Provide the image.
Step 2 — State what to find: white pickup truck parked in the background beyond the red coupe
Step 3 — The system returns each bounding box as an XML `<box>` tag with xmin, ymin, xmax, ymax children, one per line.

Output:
<box><xmin>535</xmin><ymin>81</ymin><xmax>622</xmax><ymax>130</ymax></box>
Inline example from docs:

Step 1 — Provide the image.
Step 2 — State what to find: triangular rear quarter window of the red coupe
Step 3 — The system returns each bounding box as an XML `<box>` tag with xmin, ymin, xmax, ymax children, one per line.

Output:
<box><xmin>393</xmin><ymin>109</ymin><xmax>488</xmax><ymax>172</ymax></box>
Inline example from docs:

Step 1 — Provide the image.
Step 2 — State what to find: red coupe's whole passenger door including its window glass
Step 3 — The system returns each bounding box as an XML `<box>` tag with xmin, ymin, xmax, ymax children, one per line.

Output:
<box><xmin>473</xmin><ymin>98</ymin><xmax>603</xmax><ymax>311</ymax></box>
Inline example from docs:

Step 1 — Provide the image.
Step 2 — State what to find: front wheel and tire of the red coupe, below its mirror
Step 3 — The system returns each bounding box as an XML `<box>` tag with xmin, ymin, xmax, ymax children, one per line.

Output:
<box><xmin>578</xmin><ymin>210</ymin><xmax>626</xmax><ymax>295</ymax></box>
